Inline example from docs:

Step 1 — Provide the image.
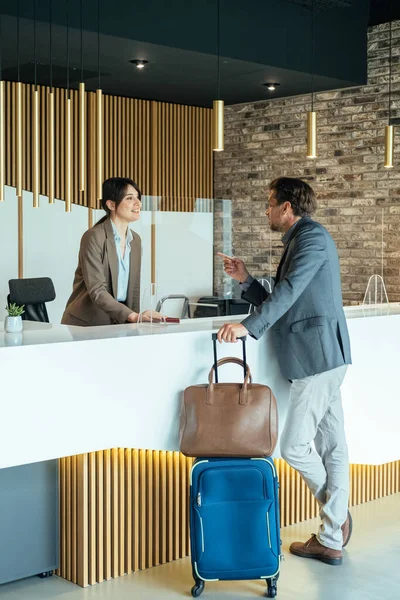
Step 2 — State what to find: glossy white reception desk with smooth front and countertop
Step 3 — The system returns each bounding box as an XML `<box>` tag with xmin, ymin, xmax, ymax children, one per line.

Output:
<box><xmin>0</xmin><ymin>304</ymin><xmax>400</xmax><ymax>468</ymax></box>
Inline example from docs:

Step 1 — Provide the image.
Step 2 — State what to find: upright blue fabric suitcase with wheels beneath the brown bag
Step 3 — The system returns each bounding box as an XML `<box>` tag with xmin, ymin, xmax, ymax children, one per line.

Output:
<box><xmin>190</xmin><ymin>458</ymin><xmax>281</xmax><ymax>598</ymax></box>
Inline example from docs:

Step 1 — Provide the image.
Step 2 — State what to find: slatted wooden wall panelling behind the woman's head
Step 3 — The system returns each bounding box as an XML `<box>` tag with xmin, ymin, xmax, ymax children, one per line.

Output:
<box><xmin>5</xmin><ymin>82</ymin><xmax>213</xmax><ymax>211</ymax></box>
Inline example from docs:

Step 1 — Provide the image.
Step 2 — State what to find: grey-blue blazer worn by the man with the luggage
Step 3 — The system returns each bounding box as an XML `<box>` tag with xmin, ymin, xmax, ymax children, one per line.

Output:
<box><xmin>242</xmin><ymin>217</ymin><xmax>351</xmax><ymax>380</ymax></box>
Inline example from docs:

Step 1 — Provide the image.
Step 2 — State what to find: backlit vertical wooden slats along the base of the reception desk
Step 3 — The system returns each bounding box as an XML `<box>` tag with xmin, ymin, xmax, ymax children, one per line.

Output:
<box><xmin>57</xmin><ymin>448</ymin><xmax>400</xmax><ymax>586</ymax></box>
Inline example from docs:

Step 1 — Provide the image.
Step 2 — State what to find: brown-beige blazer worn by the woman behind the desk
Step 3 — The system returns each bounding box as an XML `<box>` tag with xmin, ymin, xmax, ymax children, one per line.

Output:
<box><xmin>61</xmin><ymin>219</ymin><xmax>142</xmax><ymax>326</ymax></box>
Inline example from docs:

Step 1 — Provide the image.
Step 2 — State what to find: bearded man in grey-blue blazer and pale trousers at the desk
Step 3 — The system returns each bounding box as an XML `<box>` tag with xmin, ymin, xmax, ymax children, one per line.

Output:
<box><xmin>218</xmin><ymin>177</ymin><xmax>352</xmax><ymax>565</ymax></box>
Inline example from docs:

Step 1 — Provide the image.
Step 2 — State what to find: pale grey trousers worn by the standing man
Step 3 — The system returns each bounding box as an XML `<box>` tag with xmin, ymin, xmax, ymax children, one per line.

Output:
<box><xmin>281</xmin><ymin>365</ymin><xmax>349</xmax><ymax>550</ymax></box>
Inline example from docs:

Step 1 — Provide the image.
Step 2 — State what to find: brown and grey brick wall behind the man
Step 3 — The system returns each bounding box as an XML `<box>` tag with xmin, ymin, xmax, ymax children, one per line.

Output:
<box><xmin>214</xmin><ymin>21</ymin><xmax>400</xmax><ymax>304</ymax></box>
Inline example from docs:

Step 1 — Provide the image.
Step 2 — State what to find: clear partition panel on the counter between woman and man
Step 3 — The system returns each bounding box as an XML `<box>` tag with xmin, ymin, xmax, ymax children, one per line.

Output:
<box><xmin>131</xmin><ymin>196</ymin><xmax>225</xmax><ymax>318</ymax></box>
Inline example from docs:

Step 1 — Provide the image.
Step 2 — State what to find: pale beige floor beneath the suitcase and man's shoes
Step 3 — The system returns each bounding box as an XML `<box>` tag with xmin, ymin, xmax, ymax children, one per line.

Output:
<box><xmin>0</xmin><ymin>494</ymin><xmax>400</xmax><ymax>600</ymax></box>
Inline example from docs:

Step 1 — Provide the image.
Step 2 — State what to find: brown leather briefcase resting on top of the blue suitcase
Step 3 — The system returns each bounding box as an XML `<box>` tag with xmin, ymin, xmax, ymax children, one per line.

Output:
<box><xmin>180</xmin><ymin>341</ymin><xmax>278</xmax><ymax>457</ymax></box>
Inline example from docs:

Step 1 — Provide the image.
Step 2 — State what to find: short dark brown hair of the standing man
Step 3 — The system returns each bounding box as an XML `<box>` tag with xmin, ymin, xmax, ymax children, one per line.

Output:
<box><xmin>269</xmin><ymin>177</ymin><xmax>317</xmax><ymax>217</ymax></box>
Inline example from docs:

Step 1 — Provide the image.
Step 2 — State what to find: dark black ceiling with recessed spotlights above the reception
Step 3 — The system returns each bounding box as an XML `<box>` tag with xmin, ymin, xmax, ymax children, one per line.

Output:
<box><xmin>0</xmin><ymin>0</ymin><xmax>388</xmax><ymax>106</ymax></box>
